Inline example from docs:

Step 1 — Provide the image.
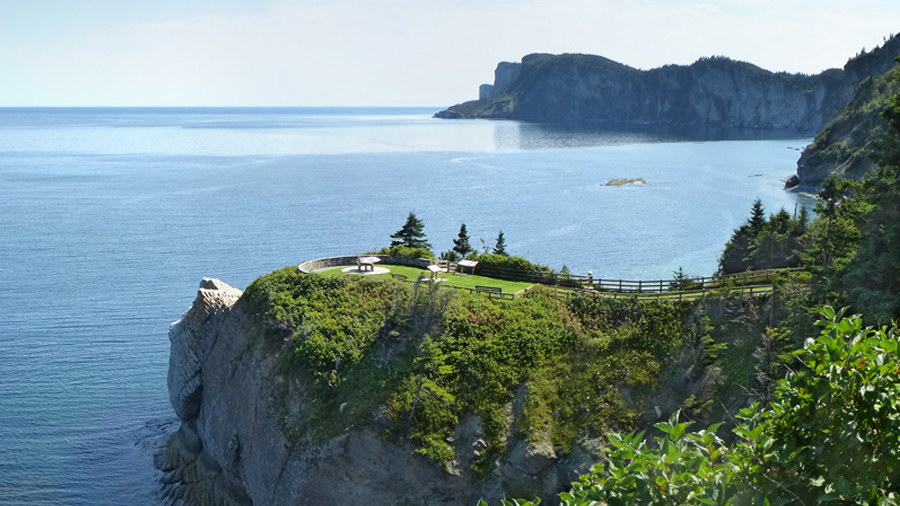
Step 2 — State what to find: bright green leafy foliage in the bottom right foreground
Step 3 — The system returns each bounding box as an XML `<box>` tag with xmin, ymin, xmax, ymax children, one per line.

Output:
<box><xmin>506</xmin><ymin>307</ymin><xmax>900</xmax><ymax>506</ymax></box>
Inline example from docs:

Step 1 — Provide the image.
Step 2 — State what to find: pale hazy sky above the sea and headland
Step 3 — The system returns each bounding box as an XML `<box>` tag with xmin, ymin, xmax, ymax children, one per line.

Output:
<box><xmin>0</xmin><ymin>0</ymin><xmax>900</xmax><ymax>106</ymax></box>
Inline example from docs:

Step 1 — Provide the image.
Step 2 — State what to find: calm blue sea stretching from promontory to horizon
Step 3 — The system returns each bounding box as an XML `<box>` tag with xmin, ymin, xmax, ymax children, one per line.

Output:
<box><xmin>0</xmin><ymin>108</ymin><xmax>810</xmax><ymax>505</ymax></box>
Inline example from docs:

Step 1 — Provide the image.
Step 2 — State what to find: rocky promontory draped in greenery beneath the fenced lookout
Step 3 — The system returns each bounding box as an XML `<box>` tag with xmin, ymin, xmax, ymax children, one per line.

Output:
<box><xmin>158</xmin><ymin>255</ymin><xmax>796</xmax><ymax>506</ymax></box>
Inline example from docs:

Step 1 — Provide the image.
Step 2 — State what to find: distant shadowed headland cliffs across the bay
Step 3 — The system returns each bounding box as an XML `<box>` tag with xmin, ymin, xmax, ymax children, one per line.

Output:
<box><xmin>435</xmin><ymin>37</ymin><xmax>900</xmax><ymax>132</ymax></box>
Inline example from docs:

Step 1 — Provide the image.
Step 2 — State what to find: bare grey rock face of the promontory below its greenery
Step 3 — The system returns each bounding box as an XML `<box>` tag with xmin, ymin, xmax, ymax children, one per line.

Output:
<box><xmin>160</xmin><ymin>279</ymin><xmax>594</xmax><ymax>506</ymax></box>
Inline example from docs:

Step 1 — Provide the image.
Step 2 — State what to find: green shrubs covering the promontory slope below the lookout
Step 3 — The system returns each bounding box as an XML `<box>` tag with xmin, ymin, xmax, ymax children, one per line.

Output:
<box><xmin>243</xmin><ymin>268</ymin><xmax>762</xmax><ymax>473</ymax></box>
